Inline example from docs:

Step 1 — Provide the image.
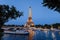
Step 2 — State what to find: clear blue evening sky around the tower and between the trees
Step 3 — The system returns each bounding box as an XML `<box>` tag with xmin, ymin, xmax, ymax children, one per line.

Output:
<box><xmin>0</xmin><ymin>0</ymin><xmax>60</xmax><ymax>25</ymax></box>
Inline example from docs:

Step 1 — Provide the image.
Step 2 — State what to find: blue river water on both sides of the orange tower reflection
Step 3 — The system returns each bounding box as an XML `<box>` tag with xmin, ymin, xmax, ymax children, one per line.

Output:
<box><xmin>2</xmin><ymin>30</ymin><xmax>60</xmax><ymax>40</ymax></box>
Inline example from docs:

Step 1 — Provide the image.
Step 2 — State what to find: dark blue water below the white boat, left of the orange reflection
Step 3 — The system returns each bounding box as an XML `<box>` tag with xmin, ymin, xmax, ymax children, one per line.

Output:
<box><xmin>3</xmin><ymin>34</ymin><xmax>28</xmax><ymax>40</ymax></box>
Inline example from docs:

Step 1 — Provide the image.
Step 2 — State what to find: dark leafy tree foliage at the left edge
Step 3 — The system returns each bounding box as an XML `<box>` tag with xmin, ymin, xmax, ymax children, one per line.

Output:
<box><xmin>0</xmin><ymin>5</ymin><xmax>22</xmax><ymax>32</ymax></box>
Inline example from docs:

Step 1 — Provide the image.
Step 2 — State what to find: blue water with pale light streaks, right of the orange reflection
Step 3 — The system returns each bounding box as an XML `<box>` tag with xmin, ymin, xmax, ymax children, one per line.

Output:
<box><xmin>33</xmin><ymin>30</ymin><xmax>60</xmax><ymax>40</ymax></box>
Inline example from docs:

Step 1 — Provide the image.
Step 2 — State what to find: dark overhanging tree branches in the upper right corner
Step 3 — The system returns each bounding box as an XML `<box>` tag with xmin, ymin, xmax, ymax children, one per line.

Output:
<box><xmin>42</xmin><ymin>0</ymin><xmax>60</xmax><ymax>13</ymax></box>
